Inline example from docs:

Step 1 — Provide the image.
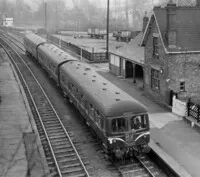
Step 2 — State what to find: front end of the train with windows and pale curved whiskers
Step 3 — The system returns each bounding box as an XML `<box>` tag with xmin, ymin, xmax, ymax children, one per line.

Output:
<box><xmin>107</xmin><ymin>114</ymin><xmax>150</xmax><ymax>156</ymax></box>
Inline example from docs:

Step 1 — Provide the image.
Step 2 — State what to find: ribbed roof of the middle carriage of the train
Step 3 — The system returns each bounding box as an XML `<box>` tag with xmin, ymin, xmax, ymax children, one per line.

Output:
<box><xmin>38</xmin><ymin>43</ymin><xmax>77</xmax><ymax>65</ymax></box>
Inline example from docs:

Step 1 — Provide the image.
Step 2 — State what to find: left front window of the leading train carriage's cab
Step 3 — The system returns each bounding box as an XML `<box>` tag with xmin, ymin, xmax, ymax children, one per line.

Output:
<box><xmin>112</xmin><ymin>118</ymin><xmax>128</xmax><ymax>132</ymax></box>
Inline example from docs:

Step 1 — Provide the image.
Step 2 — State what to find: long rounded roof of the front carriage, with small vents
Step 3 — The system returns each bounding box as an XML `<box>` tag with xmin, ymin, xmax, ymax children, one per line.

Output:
<box><xmin>61</xmin><ymin>61</ymin><xmax>147</xmax><ymax>117</ymax></box>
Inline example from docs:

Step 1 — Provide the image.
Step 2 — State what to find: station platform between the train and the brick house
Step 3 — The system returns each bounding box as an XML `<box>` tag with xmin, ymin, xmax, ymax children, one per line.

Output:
<box><xmin>96</xmin><ymin>68</ymin><xmax>200</xmax><ymax>177</ymax></box>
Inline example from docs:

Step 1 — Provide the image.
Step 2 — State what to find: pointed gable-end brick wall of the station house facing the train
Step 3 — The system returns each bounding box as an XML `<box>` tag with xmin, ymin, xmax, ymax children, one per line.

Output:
<box><xmin>144</xmin><ymin>18</ymin><xmax>169</xmax><ymax>103</ymax></box>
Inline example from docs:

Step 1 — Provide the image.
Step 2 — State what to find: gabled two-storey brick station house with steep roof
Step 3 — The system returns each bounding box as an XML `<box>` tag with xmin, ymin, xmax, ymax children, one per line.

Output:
<box><xmin>141</xmin><ymin>0</ymin><xmax>200</xmax><ymax>105</ymax></box>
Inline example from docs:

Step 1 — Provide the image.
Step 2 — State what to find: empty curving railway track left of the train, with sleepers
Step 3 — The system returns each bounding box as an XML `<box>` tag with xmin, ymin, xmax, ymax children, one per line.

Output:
<box><xmin>0</xmin><ymin>37</ymin><xmax>90</xmax><ymax>177</ymax></box>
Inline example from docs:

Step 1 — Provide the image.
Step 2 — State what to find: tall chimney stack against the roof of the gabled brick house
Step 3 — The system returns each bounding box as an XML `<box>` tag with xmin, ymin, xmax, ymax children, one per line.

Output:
<box><xmin>166</xmin><ymin>0</ymin><xmax>176</xmax><ymax>48</ymax></box>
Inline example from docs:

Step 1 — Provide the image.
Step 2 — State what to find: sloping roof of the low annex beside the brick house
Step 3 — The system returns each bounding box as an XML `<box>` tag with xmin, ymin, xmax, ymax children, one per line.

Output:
<box><xmin>110</xmin><ymin>32</ymin><xmax>144</xmax><ymax>64</ymax></box>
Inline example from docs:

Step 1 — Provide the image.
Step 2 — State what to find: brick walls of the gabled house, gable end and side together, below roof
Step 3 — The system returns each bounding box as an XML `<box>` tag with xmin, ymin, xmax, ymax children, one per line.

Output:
<box><xmin>144</xmin><ymin>17</ymin><xmax>200</xmax><ymax>104</ymax></box>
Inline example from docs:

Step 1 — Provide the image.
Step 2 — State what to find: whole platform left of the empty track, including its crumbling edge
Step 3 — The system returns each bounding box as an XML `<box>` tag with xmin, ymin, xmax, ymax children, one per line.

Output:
<box><xmin>0</xmin><ymin>48</ymin><xmax>46</xmax><ymax>177</ymax></box>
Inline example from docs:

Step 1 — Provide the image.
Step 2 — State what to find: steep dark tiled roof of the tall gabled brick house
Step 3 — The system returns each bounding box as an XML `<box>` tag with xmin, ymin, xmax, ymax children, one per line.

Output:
<box><xmin>141</xmin><ymin>7</ymin><xmax>200</xmax><ymax>52</ymax></box>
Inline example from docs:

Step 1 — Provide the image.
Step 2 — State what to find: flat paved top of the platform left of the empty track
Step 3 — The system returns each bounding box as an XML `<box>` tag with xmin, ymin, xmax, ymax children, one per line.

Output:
<box><xmin>0</xmin><ymin>48</ymin><xmax>32</xmax><ymax>177</ymax></box>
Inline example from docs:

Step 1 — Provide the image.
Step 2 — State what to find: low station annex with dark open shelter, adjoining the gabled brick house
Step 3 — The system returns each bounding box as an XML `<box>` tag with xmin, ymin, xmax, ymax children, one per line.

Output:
<box><xmin>109</xmin><ymin>14</ymin><xmax>148</xmax><ymax>87</ymax></box>
